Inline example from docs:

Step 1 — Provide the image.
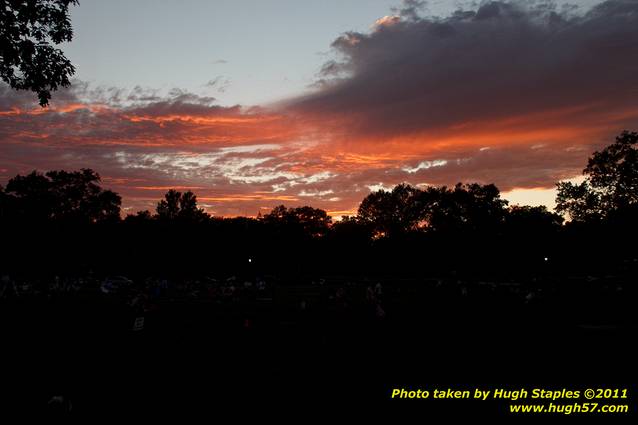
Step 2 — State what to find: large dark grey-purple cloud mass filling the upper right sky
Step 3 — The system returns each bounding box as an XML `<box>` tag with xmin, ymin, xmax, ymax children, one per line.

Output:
<box><xmin>290</xmin><ymin>0</ymin><xmax>638</xmax><ymax>138</ymax></box>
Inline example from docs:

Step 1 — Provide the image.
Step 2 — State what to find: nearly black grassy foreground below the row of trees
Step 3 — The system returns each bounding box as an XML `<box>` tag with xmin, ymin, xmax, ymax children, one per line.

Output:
<box><xmin>1</xmin><ymin>277</ymin><xmax>637</xmax><ymax>421</ymax></box>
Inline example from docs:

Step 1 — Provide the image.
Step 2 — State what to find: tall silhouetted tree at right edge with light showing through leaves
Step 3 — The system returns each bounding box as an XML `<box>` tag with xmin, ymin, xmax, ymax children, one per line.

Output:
<box><xmin>556</xmin><ymin>131</ymin><xmax>638</xmax><ymax>222</ymax></box>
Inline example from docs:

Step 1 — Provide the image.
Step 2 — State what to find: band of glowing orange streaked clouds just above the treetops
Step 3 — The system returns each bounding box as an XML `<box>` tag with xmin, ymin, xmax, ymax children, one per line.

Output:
<box><xmin>0</xmin><ymin>88</ymin><xmax>638</xmax><ymax>217</ymax></box>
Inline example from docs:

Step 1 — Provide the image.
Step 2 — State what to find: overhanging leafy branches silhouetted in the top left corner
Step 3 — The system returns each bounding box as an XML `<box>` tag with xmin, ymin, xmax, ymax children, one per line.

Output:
<box><xmin>0</xmin><ymin>0</ymin><xmax>78</xmax><ymax>106</ymax></box>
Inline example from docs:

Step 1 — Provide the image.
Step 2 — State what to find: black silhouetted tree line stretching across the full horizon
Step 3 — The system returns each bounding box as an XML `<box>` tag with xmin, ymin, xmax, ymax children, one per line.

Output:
<box><xmin>0</xmin><ymin>131</ymin><xmax>638</xmax><ymax>272</ymax></box>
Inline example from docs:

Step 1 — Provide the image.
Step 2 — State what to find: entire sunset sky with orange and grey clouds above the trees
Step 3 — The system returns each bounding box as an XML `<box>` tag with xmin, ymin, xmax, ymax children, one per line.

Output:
<box><xmin>0</xmin><ymin>0</ymin><xmax>638</xmax><ymax>216</ymax></box>
